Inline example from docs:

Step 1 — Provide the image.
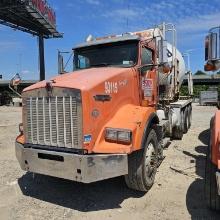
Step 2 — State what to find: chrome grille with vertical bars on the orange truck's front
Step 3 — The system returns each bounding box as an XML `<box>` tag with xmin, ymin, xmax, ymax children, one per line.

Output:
<box><xmin>25</xmin><ymin>96</ymin><xmax>82</xmax><ymax>149</ymax></box>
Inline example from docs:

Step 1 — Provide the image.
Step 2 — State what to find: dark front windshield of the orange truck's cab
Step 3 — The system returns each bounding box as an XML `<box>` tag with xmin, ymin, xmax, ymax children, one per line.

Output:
<box><xmin>74</xmin><ymin>41</ymin><xmax>138</xmax><ymax>69</ymax></box>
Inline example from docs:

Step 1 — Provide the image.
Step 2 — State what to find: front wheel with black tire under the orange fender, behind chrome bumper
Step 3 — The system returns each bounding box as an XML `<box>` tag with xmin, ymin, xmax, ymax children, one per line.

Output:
<box><xmin>125</xmin><ymin>129</ymin><xmax>158</xmax><ymax>192</ymax></box>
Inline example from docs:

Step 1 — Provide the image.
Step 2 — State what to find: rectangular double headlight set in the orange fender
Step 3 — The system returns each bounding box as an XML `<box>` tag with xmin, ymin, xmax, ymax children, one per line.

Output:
<box><xmin>105</xmin><ymin>128</ymin><xmax>132</xmax><ymax>144</ymax></box>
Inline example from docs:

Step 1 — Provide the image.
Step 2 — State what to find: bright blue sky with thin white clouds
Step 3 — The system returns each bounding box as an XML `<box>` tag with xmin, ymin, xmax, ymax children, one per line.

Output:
<box><xmin>0</xmin><ymin>0</ymin><xmax>220</xmax><ymax>79</ymax></box>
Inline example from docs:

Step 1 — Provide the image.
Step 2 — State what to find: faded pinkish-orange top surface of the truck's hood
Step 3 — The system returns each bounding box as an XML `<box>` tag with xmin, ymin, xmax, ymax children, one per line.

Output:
<box><xmin>23</xmin><ymin>67</ymin><xmax>131</xmax><ymax>92</ymax></box>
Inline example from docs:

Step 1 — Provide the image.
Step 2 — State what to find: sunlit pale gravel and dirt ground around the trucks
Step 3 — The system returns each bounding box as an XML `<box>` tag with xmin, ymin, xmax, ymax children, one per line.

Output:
<box><xmin>0</xmin><ymin>105</ymin><xmax>220</xmax><ymax>220</ymax></box>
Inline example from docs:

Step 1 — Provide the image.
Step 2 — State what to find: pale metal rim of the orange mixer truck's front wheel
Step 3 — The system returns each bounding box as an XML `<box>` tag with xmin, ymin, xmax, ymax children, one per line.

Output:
<box><xmin>145</xmin><ymin>142</ymin><xmax>156</xmax><ymax>177</ymax></box>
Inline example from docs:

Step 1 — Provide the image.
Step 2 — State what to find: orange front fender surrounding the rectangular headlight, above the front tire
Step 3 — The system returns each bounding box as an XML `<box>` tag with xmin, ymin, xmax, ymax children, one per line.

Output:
<box><xmin>92</xmin><ymin>104</ymin><xmax>155</xmax><ymax>153</ymax></box>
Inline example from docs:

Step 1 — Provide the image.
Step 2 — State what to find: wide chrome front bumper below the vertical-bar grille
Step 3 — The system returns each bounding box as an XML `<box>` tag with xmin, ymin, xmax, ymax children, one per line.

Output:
<box><xmin>15</xmin><ymin>142</ymin><xmax>128</xmax><ymax>183</ymax></box>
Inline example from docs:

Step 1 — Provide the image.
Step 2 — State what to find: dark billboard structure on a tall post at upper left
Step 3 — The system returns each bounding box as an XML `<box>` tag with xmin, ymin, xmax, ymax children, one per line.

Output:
<box><xmin>0</xmin><ymin>0</ymin><xmax>63</xmax><ymax>80</ymax></box>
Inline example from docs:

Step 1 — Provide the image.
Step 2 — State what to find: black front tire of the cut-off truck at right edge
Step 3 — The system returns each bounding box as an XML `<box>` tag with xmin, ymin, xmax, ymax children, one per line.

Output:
<box><xmin>205</xmin><ymin>147</ymin><xmax>220</xmax><ymax>211</ymax></box>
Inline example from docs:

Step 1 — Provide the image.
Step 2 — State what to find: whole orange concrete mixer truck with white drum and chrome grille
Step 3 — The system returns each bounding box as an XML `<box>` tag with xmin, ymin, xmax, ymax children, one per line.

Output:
<box><xmin>16</xmin><ymin>26</ymin><xmax>191</xmax><ymax>191</ymax></box>
